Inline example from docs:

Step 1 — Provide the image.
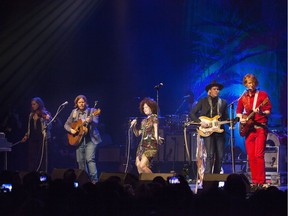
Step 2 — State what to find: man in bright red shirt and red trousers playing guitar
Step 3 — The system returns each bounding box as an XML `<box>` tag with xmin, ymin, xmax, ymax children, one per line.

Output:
<box><xmin>236</xmin><ymin>74</ymin><xmax>272</xmax><ymax>187</ymax></box>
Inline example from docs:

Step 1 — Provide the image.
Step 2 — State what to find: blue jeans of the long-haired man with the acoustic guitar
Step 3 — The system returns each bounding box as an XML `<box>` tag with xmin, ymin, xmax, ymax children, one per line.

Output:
<box><xmin>76</xmin><ymin>137</ymin><xmax>98</xmax><ymax>182</ymax></box>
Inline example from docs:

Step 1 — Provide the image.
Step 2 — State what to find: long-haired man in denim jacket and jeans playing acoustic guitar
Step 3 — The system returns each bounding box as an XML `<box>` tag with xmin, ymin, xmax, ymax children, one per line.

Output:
<box><xmin>64</xmin><ymin>95</ymin><xmax>102</xmax><ymax>183</ymax></box>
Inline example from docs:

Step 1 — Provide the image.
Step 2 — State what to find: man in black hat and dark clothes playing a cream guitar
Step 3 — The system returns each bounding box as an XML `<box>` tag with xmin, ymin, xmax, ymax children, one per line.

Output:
<box><xmin>190</xmin><ymin>81</ymin><xmax>228</xmax><ymax>173</ymax></box>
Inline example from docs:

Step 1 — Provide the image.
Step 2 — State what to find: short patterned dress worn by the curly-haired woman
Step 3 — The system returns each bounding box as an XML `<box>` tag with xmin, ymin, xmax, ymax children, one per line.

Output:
<box><xmin>137</xmin><ymin>114</ymin><xmax>158</xmax><ymax>162</ymax></box>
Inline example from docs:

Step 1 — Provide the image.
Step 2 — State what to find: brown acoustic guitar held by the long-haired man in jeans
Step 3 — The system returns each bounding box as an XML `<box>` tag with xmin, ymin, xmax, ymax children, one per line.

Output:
<box><xmin>67</xmin><ymin>109</ymin><xmax>101</xmax><ymax>146</ymax></box>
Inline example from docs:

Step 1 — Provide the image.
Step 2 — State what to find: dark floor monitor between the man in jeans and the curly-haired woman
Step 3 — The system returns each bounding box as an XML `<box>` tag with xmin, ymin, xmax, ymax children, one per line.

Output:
<box><xmin>99</xmin><ymin>172</ymin><xmax>139</xmax><ymax>186</ymax></box>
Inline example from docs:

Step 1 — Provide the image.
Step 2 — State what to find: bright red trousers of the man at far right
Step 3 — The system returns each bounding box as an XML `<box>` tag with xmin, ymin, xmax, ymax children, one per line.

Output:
<box><xmin>245</xmin><ymin>128</ymin><xmax>267</xmax><ymax>184</ymax></box>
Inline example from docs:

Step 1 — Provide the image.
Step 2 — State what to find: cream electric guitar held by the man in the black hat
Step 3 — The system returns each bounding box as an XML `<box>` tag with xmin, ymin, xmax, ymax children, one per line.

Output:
<box><xmin>185</xmin><ymin>115</ymin><xmax>233</xmax><ymax>137</ymax></box>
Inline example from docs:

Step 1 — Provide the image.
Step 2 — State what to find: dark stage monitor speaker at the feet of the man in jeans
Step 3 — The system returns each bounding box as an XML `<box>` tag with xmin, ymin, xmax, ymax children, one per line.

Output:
<box><xmin>51</xmin><ymin>168</ymin><xmax>90</xmax><ymax>186</ymax></box>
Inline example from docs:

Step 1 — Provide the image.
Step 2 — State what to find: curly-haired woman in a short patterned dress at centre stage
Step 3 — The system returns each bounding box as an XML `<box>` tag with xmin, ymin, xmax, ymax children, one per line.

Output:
<box><xmin>130</xmin><ymin>98</ymin><xmax>163</xmax><ymax>174</ymax></box>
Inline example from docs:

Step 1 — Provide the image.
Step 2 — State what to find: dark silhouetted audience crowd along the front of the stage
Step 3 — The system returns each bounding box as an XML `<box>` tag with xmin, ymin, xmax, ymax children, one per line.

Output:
<box><xmin>0</xmin><ymin>169</ymin><xmax>287</xmax><ymax>216</ymax></box>
